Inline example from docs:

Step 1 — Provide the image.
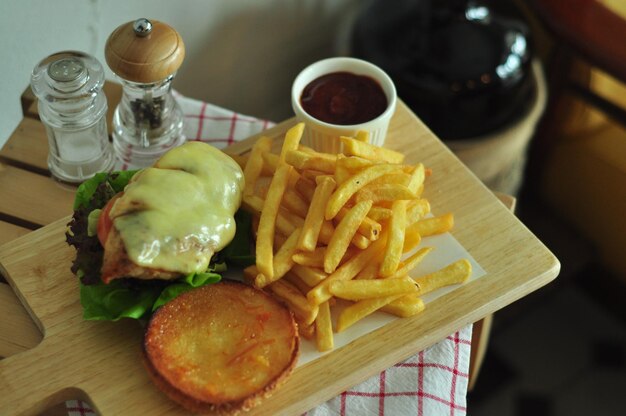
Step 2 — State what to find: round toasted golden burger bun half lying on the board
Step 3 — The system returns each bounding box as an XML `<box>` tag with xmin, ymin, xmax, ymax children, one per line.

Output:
<box><xmin>144</xmin><ymin>282</ymin><xmax>299</xmax><ymax>415</ymax></box>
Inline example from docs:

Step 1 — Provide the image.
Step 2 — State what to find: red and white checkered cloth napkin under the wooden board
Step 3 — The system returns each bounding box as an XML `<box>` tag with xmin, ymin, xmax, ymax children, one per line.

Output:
<box><xmin>66</xmin><ymin>94</ymin><xmax>472</xmax><ymax>416</ymax></box>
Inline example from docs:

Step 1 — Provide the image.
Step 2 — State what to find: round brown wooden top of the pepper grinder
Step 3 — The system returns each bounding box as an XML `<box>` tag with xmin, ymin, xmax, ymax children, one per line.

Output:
<box><xmin>104</xmin><ymin>18</ymin><xmax>185</xmax><ymax>83</ymax></box>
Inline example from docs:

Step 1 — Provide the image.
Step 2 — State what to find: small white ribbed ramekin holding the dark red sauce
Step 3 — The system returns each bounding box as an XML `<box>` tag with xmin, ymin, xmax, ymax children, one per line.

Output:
<box><xmin>291</xmin><ymin>57</ymin><xmax>397</xmax><ymax>153</ymax></box>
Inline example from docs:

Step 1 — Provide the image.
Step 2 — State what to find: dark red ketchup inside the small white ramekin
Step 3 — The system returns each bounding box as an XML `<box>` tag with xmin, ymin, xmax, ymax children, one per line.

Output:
<box><xmin>300</xmin><ymin>72</ymin><xmax>387</xmax><ymax>126</ymax></box>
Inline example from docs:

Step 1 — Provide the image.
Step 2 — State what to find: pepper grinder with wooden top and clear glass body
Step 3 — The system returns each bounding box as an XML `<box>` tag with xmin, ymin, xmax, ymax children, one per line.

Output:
<box><xmin>105</xmin><ymin>18</ymin><xmax>185</xmax><ymax>167</ymax></box>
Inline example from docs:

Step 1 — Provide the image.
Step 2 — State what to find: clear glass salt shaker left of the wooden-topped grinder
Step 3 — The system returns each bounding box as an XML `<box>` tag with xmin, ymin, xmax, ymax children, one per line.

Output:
<box><xmin>31</xmin><ymin>51</ymin><xmax>115</xmax><ymax>183</ymax></box>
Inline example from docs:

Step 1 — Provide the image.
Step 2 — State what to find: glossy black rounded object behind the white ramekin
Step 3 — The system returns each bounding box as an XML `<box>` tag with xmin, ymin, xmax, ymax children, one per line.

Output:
<box><xmin>351</xmin><ymin>0</ymin><xmax>534</xmax><ymax>140</ymax></box>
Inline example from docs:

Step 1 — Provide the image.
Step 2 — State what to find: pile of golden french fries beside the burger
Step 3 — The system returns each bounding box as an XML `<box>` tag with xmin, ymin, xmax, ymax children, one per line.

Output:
<box><xmin>238</xmin><ymin>123</ymin><xmax>471</xmax><ymax>351</ymax></box>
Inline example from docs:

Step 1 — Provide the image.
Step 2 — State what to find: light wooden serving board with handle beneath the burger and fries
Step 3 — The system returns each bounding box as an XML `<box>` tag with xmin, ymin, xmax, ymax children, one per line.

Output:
<box><xmin>0</xmin><ymin>103</ymin><xmax>560</xmax><ymax>416</ymax></box>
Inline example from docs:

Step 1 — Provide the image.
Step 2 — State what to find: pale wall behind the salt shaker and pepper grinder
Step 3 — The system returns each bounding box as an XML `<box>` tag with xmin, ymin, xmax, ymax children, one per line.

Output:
<box><xmin>0</xmin><ymin>0</ymin><xmax>358</xmax><ymax>146</ymax></box>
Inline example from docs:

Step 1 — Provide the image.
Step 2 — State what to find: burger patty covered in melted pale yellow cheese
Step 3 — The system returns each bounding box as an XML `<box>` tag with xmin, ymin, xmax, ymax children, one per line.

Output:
<box><xmin>110</xmin><ymin>142</ymin><xmax>244</xmax><ymax>274</ymax></box>
